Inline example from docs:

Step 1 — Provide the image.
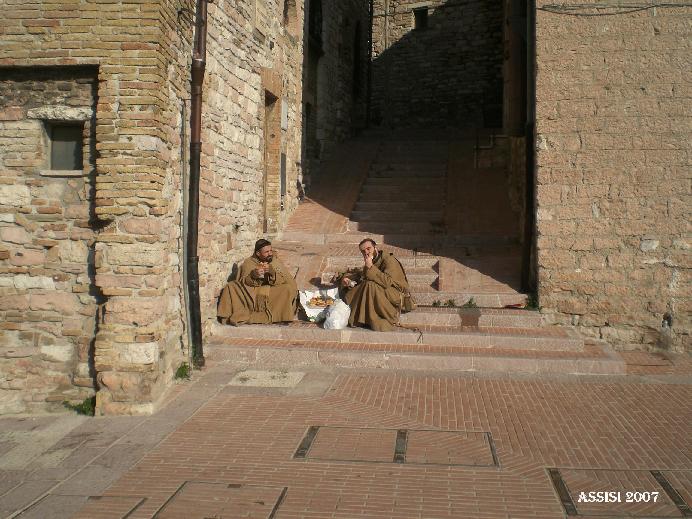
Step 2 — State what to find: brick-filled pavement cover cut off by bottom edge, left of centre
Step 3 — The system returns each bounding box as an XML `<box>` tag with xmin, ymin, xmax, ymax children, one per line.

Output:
<box><xmin>154</xmin><ymin>481</ymin><xmax>286</xmax><ymax>519</ymax></box>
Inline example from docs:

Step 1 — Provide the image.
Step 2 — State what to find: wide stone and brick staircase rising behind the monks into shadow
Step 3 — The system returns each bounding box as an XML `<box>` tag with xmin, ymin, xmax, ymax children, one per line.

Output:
<box><xmin>207</xmin><ymin>132</ymin><xmax>624</xmax><ymax>374</ymax></box>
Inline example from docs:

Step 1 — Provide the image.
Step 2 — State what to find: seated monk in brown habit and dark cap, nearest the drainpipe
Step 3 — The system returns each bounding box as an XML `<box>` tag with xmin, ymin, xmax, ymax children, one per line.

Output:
<box><xmin>217</xmin><ymin>240</ymin><xmax>298</xmax><ymax>326</ymax></box>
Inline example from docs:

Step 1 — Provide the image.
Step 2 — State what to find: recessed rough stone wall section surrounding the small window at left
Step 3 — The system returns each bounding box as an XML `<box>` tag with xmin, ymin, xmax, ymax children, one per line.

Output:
<box><xmin>0</xmin><ymin>67</ymin><xmax>99</xmax><ymax>413</ymax></box>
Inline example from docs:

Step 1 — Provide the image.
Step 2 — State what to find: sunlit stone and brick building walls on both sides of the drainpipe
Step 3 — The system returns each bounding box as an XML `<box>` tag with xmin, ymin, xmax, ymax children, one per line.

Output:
<box><xmin>0</xmin><ymin>0</ymin><xmax>303</xmax><ymax>414</ymax></box>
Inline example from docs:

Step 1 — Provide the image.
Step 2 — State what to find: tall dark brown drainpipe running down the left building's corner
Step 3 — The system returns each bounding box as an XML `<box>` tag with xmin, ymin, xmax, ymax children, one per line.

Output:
<box><xmin>185</xmin><ymin>0</ymin><xmax>207</xmax><ymax>367</ymax></box>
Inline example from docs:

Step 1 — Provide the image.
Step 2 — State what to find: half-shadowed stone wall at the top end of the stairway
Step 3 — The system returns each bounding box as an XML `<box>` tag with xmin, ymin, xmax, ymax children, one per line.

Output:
<box><xmin>372</xmin><ymin>0</ymin><xmax>503</xmax><ymax>127</ymax></box>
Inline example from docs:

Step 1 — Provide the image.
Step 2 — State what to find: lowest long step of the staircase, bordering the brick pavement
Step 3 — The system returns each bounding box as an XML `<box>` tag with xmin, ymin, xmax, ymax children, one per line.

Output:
<box><xmin>205</xmin><ymin>342</ymin><xmax>627</xmax><ymax>375</ymax></box>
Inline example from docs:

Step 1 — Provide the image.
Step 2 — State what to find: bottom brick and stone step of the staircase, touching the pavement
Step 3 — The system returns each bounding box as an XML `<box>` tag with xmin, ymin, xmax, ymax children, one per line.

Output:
<box><xmin>205</xmin><ymin>336</ymin><xmax>626</xmax><ymax>375</ymax></box>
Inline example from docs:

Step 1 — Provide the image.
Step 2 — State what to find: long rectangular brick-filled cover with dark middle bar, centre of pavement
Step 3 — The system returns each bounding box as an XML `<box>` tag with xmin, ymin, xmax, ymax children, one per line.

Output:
<box><xmin>293</xmin><ymin>426</ymin><xmax>499</xmax><ymax>467</ymax></box>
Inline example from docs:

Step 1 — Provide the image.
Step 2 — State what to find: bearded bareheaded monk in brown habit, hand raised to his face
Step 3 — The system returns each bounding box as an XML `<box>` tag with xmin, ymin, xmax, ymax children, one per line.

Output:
<box><xmin>341</xmin><ymin>238</ymin><xmax>413</xmax><ymax>332</ymax></box>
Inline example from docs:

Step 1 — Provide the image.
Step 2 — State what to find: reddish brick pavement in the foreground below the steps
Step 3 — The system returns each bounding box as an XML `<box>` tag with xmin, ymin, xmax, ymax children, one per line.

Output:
<box><xmin>0</xmin><ymin>354</ymin><xmax>692</xmax><ymax>519</ymax></box>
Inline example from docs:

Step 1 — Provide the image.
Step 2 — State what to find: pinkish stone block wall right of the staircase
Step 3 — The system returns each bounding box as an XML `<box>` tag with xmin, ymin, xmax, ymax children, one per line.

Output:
<box><xmin>536</xmin><ymin>2</ymin><xmax>692</xmax><ymax>350</ymax></box>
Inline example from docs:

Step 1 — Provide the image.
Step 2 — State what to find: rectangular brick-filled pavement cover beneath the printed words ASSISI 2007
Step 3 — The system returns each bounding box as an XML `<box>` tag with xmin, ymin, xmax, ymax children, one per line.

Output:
<box><xmin>548</xmin><ymin>468</ymin><xmax>692</xmax><ymax>519</ymax></box>
